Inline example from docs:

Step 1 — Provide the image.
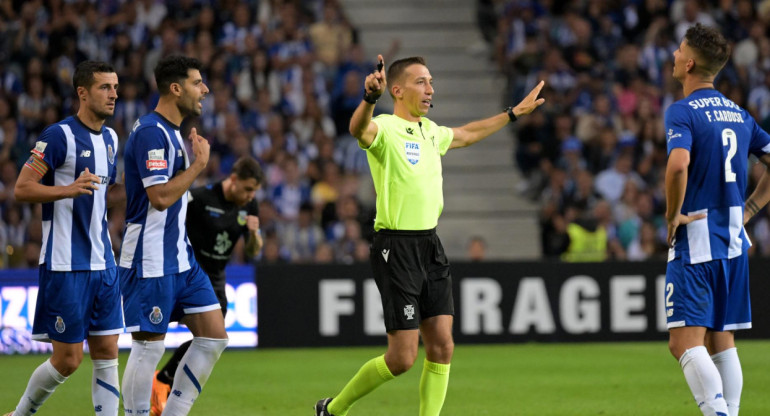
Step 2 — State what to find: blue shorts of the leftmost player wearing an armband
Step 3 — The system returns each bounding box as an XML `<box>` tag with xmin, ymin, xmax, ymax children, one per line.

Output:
<box><xmin>32</xmin><ymin>264</ymin><xmax>123</xmax><ymax>343</ymax></box>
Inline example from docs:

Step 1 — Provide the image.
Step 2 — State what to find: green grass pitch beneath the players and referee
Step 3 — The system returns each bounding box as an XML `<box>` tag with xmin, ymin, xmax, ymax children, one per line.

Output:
<box><xmin>0</xmin><ymin>341</ymin><xmax>770</xmax><ymax>416</ymax></box>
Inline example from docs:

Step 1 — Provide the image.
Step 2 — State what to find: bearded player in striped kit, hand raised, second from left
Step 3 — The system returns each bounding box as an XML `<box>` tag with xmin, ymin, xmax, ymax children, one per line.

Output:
<box><xmin>118</xmin><ymin>55</ymin><xmax>227</xmax><ymax>415</ymax></box>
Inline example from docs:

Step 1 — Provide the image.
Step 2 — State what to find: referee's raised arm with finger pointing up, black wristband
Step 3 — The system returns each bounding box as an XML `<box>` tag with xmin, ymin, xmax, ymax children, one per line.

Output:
<box><xmin>349</xmin><ymin>55</ymin><xmax>388</xmax><ymax>147</ymax></box>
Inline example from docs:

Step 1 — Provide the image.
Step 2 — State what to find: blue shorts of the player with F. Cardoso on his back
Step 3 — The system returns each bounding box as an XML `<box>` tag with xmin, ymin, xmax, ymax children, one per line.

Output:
<box><xmin>664</xmin><ymin>254</ymin><xmax>751</xmax><ymax>331</ymax></box>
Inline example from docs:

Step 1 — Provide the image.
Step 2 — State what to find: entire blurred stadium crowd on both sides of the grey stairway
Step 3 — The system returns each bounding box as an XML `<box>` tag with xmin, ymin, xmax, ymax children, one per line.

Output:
<box><xmin>0</xmin><ymin>0</ymin><xmax>770</xmax><ymax>267</ymax></box>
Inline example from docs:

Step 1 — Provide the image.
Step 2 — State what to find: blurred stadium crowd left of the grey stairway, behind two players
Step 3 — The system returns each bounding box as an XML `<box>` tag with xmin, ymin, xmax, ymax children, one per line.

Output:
<box><xmin>0</xmin><ymin>0</ymin><xmax>388</xmax><ymax>267</ymax></box>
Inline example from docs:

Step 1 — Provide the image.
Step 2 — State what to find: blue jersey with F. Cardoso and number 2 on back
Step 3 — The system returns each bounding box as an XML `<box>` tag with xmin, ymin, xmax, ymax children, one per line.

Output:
<box><xmin>665</xmin><ymin>88</ymin><xmax>770</xmax><ymax>264</ymax></box>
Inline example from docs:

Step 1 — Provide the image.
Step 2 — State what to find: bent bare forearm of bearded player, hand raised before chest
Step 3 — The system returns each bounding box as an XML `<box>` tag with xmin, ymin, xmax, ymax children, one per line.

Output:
<box><xmin>145</xmin><ymin>127</ymin><xmax>211</xmax><ymax>211</ymax></box>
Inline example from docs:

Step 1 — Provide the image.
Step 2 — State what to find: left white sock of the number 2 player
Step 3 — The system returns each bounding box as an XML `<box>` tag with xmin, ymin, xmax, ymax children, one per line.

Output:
<box><xmin>679</xmin><ymin>345</ymin><xmax>728</xmax><ymax>416</ymax></box>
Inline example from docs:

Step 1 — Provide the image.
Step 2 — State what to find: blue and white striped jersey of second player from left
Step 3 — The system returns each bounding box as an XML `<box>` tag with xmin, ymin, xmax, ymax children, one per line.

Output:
<box><xmin>119</xmin><ymin>112</ymin><xmax>195</xmax><ymax>277</ymax></box>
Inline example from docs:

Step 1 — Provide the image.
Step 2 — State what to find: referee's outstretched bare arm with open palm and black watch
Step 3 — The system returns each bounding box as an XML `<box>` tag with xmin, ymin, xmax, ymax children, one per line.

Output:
<box><xmin>449</xmin><ymin>81</ymin><xmax>545</xmax><ymax>149</ymax></box>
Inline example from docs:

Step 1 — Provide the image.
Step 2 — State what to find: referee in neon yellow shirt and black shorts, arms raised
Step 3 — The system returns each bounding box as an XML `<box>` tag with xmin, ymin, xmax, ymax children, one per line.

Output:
<box><xmin>315</xmin><ymin>55</ymin><xmax>544</xmax><ymax>416</ymax></box>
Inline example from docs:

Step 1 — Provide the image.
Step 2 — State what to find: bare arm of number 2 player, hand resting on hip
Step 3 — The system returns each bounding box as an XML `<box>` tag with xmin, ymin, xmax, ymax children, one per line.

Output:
<box><xmin>666</xmin><ymin>148</ymin><xmax>706</xmax><ymax>247</ymax></box>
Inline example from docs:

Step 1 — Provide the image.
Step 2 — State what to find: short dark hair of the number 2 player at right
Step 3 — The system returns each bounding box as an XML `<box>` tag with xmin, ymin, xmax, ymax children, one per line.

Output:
<box><xmin>684</xmin><ymin>23</ymin><xmax>730</xmax><ymax>76</ymax></box>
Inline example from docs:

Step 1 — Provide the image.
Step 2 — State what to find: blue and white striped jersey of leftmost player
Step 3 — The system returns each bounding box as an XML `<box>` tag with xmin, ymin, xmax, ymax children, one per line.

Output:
<box><xmin>33</xmin><ymin>117</ymin><xmax>118</xmax><ymax>271</ymax></box>
